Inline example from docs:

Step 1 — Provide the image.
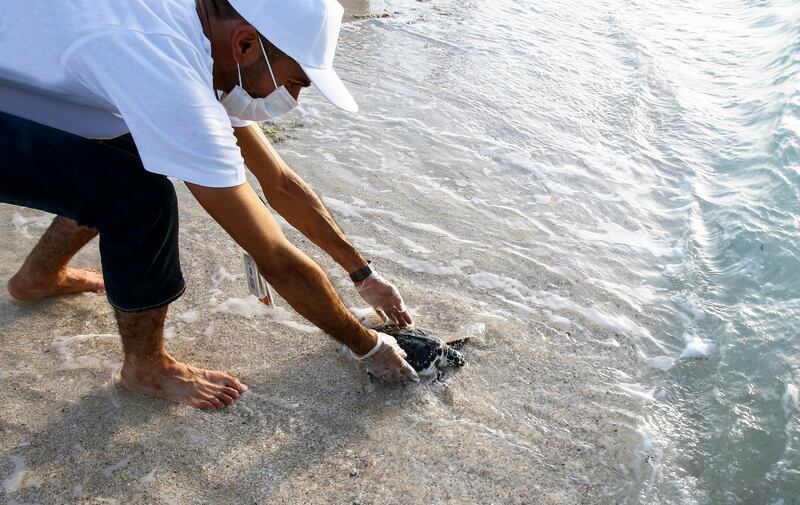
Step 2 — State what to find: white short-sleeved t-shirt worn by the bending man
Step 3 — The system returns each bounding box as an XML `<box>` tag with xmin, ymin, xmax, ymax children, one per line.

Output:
<box><xmin>0</xmin><ymin>0</ymin><xmax>249</xmax><ymax>187</ymax></box>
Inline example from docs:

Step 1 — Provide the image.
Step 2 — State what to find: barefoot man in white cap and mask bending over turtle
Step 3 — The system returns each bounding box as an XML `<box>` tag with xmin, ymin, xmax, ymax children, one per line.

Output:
<box><xmin>0</xmin><ymin>0</ymin><xmax>418</xmax><ymax>409</ymax></box>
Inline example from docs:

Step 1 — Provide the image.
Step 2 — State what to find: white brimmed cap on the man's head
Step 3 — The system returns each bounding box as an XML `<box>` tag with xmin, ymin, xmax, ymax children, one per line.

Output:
<box><xmin>228</xmin><ymin>0</ymin><xmax>358</xmax><ymax>112</ymax></box>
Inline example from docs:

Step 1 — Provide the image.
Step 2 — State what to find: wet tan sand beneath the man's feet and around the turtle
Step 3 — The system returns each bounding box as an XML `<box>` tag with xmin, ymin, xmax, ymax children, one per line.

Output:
<box><xmin>0</xmin><ymin>1</ymin><xmax>635</xmax><ymax>505</ymax></box>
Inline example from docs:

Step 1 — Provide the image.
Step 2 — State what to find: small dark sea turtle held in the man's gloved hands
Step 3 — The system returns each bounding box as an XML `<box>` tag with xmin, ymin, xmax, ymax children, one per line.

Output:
<box><xmin>373</xmin><ymin>324</ymin><xmax>468</xmax><ymax>376</ymax></box>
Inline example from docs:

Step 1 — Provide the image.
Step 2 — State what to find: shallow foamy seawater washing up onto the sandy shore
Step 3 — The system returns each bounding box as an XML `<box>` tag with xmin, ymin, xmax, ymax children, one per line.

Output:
<box><xmin>276</xmin><ymin>0</ymin><xmax>800</xmax><ymax>505</ymax></box>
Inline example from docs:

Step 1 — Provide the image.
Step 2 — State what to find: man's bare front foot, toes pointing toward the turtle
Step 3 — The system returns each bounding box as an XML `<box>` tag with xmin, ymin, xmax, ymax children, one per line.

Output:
<box><xmin>120</xmin><ymin>354</ymin><xmax>247</xmax><ymax>410</ymax></box>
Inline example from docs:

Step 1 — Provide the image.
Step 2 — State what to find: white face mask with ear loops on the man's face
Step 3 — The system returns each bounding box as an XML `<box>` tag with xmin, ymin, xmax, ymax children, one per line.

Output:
<box><xmin>220</xmin><ymin>37</ymin><xmax>297</xmax><ymax>121</ymax></box>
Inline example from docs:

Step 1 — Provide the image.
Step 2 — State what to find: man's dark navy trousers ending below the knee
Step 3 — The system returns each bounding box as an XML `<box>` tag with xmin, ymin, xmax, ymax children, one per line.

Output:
<box><xmin>0</xmin><ymin>112</ymin><xmax>185</xmax><ymax>312</ymax></box>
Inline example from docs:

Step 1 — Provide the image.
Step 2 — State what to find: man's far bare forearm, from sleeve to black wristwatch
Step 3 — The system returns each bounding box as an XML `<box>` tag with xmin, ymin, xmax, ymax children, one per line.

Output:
<box><xmin>234</xmin><ymin>124</ymin><xmax>367</xmax><ymax>273</ymax></box>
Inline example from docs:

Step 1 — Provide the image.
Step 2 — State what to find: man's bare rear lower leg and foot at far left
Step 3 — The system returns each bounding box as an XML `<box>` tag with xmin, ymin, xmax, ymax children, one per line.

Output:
<box><xmin>8</xmin><ymin>216</ymin><xmax>104</xmax><ymax>300</ymax></box>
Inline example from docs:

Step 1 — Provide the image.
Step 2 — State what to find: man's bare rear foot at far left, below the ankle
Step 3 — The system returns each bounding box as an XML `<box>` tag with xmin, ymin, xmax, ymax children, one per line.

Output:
<box><xmin>8</xmin><ymin>268</ymin><xmax>105</xmax><ymax>301</ymax></box>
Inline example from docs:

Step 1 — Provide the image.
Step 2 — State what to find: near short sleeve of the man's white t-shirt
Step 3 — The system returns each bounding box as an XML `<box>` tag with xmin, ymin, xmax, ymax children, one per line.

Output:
<box><xmin>65</xmin><ymin>31</ymin><xmax>245</xmax><ymax>187</ymax></box>
